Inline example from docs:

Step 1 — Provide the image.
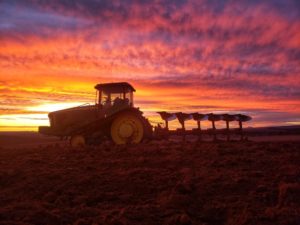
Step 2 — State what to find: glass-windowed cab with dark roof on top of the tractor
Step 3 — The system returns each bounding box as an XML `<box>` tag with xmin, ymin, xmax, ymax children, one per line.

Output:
<box><xmin>95</xmin><ymin>82</ymin><xmax>135</xmax><ymax>114</ymax></box>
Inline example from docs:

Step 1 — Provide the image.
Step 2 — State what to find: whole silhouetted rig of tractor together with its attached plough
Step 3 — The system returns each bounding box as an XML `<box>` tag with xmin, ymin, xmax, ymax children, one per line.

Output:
<box><xmin>39</xmin><ymin>82</ymin><xmax>251</xmax><ymax>146</ymax></box>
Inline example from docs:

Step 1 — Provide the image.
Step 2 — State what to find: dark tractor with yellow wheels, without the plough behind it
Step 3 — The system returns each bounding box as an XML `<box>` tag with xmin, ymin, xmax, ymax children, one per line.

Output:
<box><xmin>39</xmin><ymin>82</ymin><xmax>153</xmax><ymax>147</ymax></box>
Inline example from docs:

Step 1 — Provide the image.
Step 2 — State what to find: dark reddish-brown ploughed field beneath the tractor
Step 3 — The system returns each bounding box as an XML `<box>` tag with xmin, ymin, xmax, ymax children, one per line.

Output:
<box><xmin>0</xmin><ymin>134</ymin><xmax>300</xmax><ymax>225</ymax></box>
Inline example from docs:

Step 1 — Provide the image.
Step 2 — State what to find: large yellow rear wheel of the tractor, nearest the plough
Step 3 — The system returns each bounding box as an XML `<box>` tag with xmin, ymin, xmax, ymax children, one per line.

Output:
<box><xmin>111</xmin><ymin>113</ymin><xmax>144</xmax><ymax>145</ymax></box>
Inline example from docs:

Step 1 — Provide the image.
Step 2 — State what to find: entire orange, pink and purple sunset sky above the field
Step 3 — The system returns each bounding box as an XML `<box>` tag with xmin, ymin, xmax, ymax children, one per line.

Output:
<box><xmin>0</xmin><ymin>0</ymin><xmax>300</xmax><ymax>131</ymax></box>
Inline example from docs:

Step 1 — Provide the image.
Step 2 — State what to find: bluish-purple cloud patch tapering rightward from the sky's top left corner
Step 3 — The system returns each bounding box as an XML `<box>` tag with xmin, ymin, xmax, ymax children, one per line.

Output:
<box><xmin>0</xmin><ymin>1</ymin><xmax>89</xmax><ymax>40</ymax></box>
